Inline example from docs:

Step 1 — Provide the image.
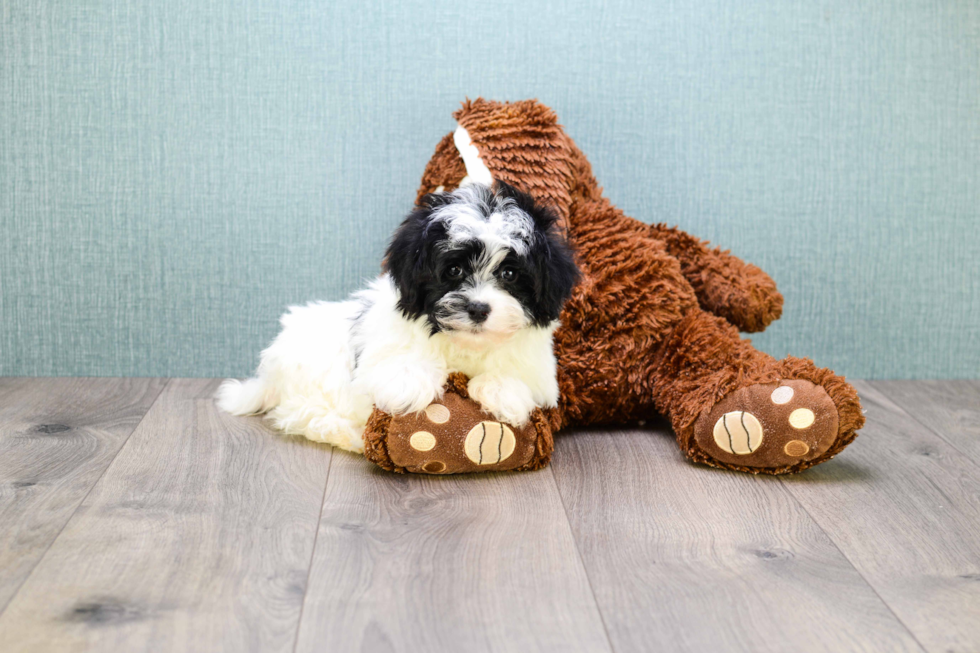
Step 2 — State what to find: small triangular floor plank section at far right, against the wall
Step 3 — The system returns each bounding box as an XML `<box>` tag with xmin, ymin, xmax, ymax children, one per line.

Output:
<box><xmin>869</xmin><ymin>380</ymin><xmax>980</xmax><ymax>463</ymax></box>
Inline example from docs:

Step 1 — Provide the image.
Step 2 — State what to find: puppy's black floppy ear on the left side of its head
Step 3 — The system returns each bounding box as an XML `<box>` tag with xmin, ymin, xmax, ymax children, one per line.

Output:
<box><xmin>383</xmin><ymin>193</ymin><xmax>449</xmax><ymax>319</ymax></box>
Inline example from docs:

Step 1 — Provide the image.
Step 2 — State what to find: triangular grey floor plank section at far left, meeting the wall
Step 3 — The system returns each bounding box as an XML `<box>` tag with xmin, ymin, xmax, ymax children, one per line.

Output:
<box><xmin>0</xmin><ymin>378</ymin><xmax>165</xmax><ymax>612</ymax></box>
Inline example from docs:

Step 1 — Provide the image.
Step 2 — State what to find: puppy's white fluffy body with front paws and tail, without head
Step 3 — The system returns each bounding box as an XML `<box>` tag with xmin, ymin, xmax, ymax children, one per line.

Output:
<box><xmin>218</xmin><ymin>274</ymin><xmax>558</xmax><ymax>452</ymax></box>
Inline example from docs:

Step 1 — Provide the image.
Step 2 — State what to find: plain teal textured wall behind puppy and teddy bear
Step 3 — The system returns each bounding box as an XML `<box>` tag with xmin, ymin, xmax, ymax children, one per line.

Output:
<box><xmin>0</xmin><ymin>0</ymin><xmax>980</xmax><ymax>378</ymax></box>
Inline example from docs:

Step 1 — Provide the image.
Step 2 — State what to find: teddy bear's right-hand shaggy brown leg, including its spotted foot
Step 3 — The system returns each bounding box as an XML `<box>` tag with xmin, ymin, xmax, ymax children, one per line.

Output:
<box><xmin>653</xmin><ymin>310</ymin><xmax>864</xmax><ymax>474</ymax></box>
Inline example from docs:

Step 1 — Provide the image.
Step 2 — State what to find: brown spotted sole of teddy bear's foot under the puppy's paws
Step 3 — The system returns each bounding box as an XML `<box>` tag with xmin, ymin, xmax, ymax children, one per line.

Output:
<box><xmin>388</xmin><ymin>393</ymin><xmax>537</xmax><ymax>474</ymax></box>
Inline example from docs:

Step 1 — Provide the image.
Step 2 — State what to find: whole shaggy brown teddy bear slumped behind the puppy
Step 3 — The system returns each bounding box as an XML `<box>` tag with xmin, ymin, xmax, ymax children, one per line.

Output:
<box><xmin>364</xmin><ymin>99</ymin><xmax>864</xmax><ymax>474</ymax></box>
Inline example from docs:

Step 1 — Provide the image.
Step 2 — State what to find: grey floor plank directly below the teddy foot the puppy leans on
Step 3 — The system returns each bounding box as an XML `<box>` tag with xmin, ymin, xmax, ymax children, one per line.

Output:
<box><xmin>297</xmin><ymin>453</ymin><xmax>609</xmax><ymax>652</ymax></box>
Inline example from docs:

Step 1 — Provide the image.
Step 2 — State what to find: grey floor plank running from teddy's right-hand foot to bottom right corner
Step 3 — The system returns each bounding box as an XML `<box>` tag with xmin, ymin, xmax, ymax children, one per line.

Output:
<box><xmin>782</xmin><ymin>382</ymin><xmax>980</xmax><ymax>653</ymax></box>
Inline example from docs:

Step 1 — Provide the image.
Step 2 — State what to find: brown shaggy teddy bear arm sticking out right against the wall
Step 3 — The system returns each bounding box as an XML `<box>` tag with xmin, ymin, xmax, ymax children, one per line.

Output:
<box><xmin>651</xmin><ymin>224</ymin><xmax>783</xmax><ymax>333</ymax></box>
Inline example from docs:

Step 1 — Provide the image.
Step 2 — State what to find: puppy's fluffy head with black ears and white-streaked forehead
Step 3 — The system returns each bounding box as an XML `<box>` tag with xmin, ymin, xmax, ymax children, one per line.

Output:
<box><xmin>385</xmin><ymin>182</ymin><xmax>578</xmax><ymax>337</ymax></box>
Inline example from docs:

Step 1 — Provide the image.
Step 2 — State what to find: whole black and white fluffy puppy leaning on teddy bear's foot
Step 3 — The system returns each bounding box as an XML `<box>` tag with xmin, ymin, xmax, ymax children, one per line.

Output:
<box><xmin>218</xmin><ymin>182</ymin><xmax>578</xmax><ymax>452</ymax></box>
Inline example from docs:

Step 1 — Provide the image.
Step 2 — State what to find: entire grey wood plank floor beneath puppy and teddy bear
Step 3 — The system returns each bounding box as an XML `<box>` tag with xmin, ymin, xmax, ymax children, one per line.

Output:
<box><xmin>0</xmin><ymin>378</ymin><xmax>980</xmax><ymax>653</ymax></box>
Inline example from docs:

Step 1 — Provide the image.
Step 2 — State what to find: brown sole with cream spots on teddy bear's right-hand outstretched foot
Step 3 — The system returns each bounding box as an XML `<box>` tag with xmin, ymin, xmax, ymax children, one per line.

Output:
<box><xmin>694</xmin><ymin>379</ymin><xmax>838</xmax><ymax>467</ymax></box>
